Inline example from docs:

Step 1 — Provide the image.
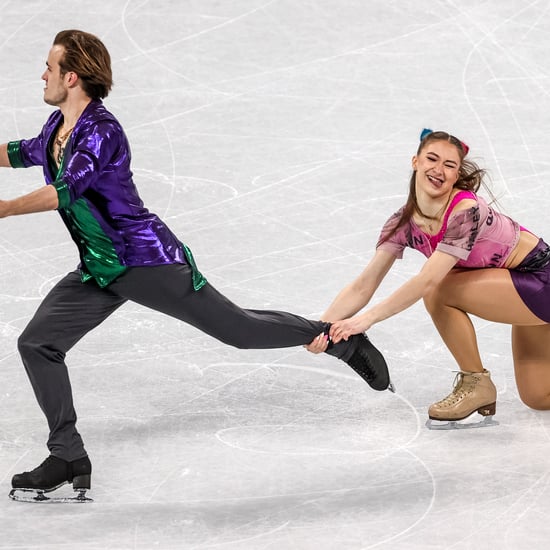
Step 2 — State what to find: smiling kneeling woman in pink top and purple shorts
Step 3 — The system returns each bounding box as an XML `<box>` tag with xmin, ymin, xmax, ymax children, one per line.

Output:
<box><xmin>307</xmin><ymin>130</ymin><xmax>550</xmax><ymax>427</ymax></box>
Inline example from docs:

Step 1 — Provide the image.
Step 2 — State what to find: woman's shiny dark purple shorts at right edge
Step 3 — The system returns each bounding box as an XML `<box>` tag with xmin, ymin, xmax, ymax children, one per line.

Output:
<box><xmin>510</xmin><ymin>239</ymin><xmax>550</xmax><ymax>323</ymax></box>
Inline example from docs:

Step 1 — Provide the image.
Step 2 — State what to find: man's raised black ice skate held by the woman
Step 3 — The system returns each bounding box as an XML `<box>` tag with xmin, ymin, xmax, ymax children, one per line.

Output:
<box><xmin>327</xmin><ymin>333</ymin><xmax>395</xmax><ymax>392</ymax></box>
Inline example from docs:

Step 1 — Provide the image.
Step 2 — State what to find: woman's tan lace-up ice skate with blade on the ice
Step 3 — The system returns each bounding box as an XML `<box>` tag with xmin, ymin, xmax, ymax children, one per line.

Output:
<box><xmin>426</xmin><ymin>369</ymin><xmax>498</xmax><ymax>430</ymax></box>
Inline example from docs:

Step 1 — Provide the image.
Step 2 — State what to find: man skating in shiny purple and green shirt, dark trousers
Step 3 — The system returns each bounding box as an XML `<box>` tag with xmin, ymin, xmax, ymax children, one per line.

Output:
<box><xmin>0</xmin><ymin>30</ymin><xmax>391</xmax><ymax>499</ymax></box>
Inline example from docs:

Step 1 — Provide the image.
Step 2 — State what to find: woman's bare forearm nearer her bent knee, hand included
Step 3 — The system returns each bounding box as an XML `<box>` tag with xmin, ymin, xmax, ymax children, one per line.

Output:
<box><xmin>330</xmin><ymin>251</ymin><xmax>458</xmax><ymax>342</ymax></box>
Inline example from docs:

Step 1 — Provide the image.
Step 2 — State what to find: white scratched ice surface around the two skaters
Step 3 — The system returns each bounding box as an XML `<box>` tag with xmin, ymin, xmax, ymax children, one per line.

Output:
<box><xmin>0</xmin><ymin>0</ymin><xmax>550</xmax><ymax>550</ymax></box>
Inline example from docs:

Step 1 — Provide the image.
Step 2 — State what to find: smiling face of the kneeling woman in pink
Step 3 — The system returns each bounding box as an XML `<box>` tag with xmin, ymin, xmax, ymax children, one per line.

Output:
<box><xmin>412</xmin><ymin>140</ymin><xmax>461</xmax><ymax>198</ymax></box>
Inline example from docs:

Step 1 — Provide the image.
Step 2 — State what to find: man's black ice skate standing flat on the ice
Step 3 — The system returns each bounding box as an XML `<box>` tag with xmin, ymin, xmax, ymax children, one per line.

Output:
<box><xmin>9</xmin><ymin>456</ymin><xmax>92</xmax><ymax>502</ymax></box>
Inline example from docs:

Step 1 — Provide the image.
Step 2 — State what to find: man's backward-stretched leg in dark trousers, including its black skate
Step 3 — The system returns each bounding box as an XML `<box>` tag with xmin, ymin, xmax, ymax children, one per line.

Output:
<box><xmin>110</xmin><ymin>264</ymin><xmax>391</xmax><ymax>390</ymax></box>
